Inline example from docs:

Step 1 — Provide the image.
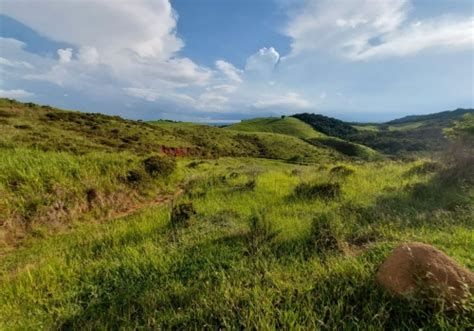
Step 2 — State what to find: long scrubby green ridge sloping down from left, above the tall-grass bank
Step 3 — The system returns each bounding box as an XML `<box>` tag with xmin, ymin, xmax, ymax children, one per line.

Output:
<box><xmin>0</xmin><ymin>99</ymin><xmax>343</xmax><ymax>162</ymax></box>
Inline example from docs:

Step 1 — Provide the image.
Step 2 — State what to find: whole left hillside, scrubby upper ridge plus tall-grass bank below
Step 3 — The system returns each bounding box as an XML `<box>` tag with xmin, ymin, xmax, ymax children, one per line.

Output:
<box><xmin>0</xmin><ymin>99</ymin><xmax>343</xmax><ymax>246</ymax></box>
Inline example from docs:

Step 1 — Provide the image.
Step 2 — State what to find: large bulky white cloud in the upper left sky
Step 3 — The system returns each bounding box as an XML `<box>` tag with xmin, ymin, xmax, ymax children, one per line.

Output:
<box><xmin>2</xmin><ymin>0</ymin><xmax>213</xmax><ymax>100</ymax></box>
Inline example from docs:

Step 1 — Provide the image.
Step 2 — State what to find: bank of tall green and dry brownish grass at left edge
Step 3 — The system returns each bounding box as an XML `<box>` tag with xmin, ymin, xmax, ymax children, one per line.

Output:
<box><xmin>0</xmin><ymin>149</ymin><xmax>178</xmax><ymax>243</ymax></box>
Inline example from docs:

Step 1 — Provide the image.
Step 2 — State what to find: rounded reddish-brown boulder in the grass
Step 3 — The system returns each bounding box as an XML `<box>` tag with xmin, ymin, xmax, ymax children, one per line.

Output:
<box><xmin>376</xmin><ymin>242</ymin><xmax>474</xmax><ymax>304</ymax></box>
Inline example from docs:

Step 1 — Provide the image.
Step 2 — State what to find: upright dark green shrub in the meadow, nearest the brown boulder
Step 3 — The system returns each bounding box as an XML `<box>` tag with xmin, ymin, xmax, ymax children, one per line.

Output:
<box><xmin>309</xmin><ymin>214</ymin><xmax>341</xmax><ymax>254</ymax></box>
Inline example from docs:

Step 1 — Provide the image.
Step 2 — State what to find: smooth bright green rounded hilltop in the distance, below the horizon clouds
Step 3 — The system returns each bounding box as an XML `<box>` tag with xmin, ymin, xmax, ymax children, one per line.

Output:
<box><xmin>226</xmin><ymin>116</ymin><xmax>323</xmax><ymax>138</ymax></box>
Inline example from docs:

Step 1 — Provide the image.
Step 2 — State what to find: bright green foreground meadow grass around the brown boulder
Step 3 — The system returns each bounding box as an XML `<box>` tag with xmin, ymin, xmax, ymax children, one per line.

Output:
<box><xmin>0</xmin><ymin>158</ymin><xmax>474</xmax><ymax>329</ymax></box>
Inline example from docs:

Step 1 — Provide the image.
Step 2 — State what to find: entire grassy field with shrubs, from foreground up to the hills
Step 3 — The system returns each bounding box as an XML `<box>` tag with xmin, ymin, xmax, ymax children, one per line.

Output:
<box><xmin>0</xmin><ymin>101</ymin><xmax>474</xmax><ymax>330</ymax></box>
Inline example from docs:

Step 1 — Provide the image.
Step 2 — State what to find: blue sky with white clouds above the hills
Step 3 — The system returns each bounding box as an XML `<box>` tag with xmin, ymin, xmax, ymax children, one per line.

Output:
<box><xmin>0</xmin><ymin>0</ymin><xmax>474</xmax><ymax>123</ymax></box>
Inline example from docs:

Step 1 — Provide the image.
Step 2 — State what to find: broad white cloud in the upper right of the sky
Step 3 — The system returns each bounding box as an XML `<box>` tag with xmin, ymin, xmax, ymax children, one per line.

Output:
<box><xmin>285</xmin><ymin>0</ymin><xmax>474</xmax><ymax>60</ymax></box>
